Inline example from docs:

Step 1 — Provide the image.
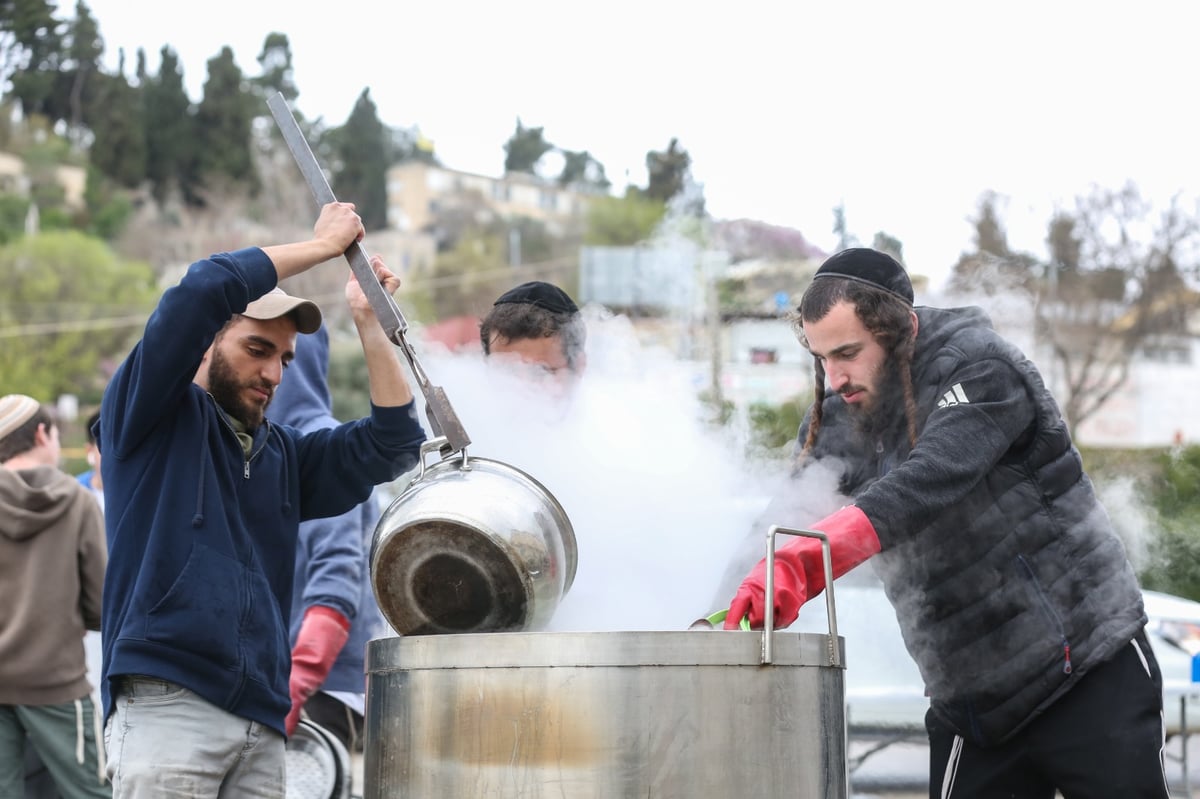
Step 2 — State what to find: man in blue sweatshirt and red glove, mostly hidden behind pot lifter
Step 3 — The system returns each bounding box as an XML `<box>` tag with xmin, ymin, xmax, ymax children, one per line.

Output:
<box><xmin>268</xmin><ymin>325</ymin><xmax>388</xmax><ymax>752</ymax></box>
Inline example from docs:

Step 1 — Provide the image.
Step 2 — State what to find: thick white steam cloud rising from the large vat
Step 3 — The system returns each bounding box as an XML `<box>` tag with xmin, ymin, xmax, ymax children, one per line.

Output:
<box><xmin>388</xmin><ymin>306</ymin><xmax>840</xmax><ymax>632</ymax></box>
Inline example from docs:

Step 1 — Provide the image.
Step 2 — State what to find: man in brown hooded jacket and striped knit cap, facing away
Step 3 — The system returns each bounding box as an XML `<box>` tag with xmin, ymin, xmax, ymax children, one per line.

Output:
<box><xmin>0</xmin><ymin>395</ymin><xmax>112</xmax><ymax>799</ymax></box>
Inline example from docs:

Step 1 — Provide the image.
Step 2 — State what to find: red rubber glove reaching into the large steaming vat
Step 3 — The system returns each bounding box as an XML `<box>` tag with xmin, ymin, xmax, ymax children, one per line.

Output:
<box><xmin>725</xmin><ymin>505</ymin><xmax>880</xmax><ymax>630</ymax></box>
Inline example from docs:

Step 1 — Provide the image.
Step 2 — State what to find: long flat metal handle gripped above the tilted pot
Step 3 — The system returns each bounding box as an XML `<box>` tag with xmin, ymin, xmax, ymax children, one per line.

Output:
<box><xmin>266</xmin><ymin>92</ymin><xmax>470</xmax><ymax>455</ymax></box>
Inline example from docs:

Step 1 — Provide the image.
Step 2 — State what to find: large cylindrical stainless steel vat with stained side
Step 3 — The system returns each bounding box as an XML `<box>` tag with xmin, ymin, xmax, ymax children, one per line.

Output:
<box><xmin>364</xmin><ymin>631</ymin><xmax>847</xmax><ymax>799</ymax></box>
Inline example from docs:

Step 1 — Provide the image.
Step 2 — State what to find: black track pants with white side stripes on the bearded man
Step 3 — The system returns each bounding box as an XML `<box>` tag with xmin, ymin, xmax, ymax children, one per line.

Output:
<box><xmin>925</xmin><ymin>632</ymin><xmax>1169</xmax><ymax>799</ymax></box>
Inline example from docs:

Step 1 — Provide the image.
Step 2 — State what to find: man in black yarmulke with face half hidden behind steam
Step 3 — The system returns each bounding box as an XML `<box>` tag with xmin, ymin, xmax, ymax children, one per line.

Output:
<box><xmin>479</xmin><ymin>281</ymin><xmax>587</xmax><ymax>379</ymax></box>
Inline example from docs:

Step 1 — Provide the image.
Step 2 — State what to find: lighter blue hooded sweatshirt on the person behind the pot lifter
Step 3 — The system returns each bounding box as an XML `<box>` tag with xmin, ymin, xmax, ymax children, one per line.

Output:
<box><xmin>266</xmin><ymin>325</ymin><xmax>388</xmax><ymax>693</ymax></box>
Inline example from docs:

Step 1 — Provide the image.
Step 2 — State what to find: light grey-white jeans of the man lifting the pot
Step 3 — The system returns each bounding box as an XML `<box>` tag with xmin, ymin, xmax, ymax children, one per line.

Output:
<box><xmin>104</xmin><ymin>677</ymin><xmax>286</xmax><ymax>799</ymax></box>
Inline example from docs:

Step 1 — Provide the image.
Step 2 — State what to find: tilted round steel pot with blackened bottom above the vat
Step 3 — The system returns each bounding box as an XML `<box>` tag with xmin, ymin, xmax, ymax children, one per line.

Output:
<box><xmin>371</xmin><ymin>439</ymin><xmax>578</xmax><ymax>636</ymax></box>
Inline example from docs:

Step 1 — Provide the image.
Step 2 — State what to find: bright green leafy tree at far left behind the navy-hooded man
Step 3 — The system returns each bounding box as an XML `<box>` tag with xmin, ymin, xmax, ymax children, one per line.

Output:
<box><xmin>0</xmin><ymin>230</ymin><xmax>157</xmax><ymax>404</ymax></box>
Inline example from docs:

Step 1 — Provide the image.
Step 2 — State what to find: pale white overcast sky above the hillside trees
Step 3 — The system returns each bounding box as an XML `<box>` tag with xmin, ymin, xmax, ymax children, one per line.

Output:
<box><xmin>79</xmin><ymin>0</ymin><xmax>1200</xmax><ymax>287</ymax></box>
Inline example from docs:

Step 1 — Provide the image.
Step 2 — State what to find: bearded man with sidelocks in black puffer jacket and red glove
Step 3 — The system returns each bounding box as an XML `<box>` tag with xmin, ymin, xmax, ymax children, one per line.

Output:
<box><xmin>726</xmin><ymin>248</ymin><xmax>1168</xmax><ymax>799</ymax></box>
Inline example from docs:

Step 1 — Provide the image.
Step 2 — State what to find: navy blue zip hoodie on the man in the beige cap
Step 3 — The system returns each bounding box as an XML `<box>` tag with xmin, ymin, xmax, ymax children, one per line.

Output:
<box><xmin>98</xmin><ymin>247</ymin><xmax>425</xmax><ymax>733</ymax></box>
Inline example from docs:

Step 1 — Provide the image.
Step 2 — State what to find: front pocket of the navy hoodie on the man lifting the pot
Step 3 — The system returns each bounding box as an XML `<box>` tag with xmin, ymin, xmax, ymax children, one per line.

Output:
<box><xmin>146</xmin><ymin>543</ymin><xmax>246</xmax><ymax>668</ymax></box>
